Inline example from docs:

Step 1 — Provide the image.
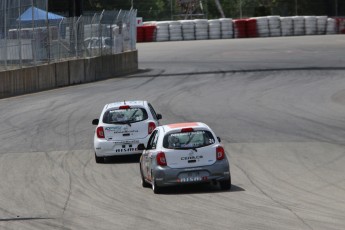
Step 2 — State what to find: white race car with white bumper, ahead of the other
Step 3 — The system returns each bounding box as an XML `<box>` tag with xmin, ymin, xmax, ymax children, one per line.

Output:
<box><xmin>92</xmin><ymin>101</ymin><xmax>162</xmax><ymax>163</ymax></box>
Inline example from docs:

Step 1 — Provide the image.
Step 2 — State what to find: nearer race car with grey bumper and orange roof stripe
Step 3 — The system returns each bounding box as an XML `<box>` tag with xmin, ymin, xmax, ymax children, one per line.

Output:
<box><xmin>138</xmin><ymin>122</ymin><xmax>231</xmax><ymax>193</ymax></box>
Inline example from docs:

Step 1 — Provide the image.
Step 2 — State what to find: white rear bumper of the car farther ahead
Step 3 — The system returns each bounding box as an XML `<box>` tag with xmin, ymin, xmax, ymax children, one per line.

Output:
<box><xmin>94</xmin><ymin>135</ymin><xmax>150</xmax><ymax>157</ymax></box>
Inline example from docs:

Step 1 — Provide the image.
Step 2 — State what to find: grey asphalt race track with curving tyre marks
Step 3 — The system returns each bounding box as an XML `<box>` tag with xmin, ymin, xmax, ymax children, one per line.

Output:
<box><xmin>0</xmin><ymin>35</ymin><xmax>345</xmax><ymax>230</ymax></box>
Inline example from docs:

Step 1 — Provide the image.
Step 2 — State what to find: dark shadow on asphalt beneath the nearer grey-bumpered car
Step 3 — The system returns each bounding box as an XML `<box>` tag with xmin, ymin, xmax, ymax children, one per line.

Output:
<box><xmin>157</xmin><ymin>184</ymin><xmax>245</xmax><ymax>195</ymax></box>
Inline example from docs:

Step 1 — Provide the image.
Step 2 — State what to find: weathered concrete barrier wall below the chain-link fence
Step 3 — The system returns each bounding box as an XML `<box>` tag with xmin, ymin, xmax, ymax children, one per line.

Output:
<box><xmin>0</xmin><ymin>51</ymin><xmax>138</xmax><ymax>98</ymax></box>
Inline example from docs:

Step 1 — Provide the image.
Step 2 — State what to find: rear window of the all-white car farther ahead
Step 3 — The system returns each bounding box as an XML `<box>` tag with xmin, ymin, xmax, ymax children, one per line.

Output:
<box><xmin>103</xmin><ymin>108</ymin><xmax>148</xmax><ymax>124</ymax></box>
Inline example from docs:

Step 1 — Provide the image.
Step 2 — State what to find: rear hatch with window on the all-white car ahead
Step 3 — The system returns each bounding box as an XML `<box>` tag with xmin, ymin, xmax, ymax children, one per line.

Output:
<box><xmin>102</xmin><ymin>106</ymin><xmax>149</xmax><ymax>141</ymax></box>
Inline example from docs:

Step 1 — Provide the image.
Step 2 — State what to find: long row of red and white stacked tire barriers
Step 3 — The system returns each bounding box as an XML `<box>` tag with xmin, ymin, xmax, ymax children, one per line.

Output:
<box><xmin>137</xmin><ymin>15</ymin><xmax>345</xmax><ymax>42</ymax></box>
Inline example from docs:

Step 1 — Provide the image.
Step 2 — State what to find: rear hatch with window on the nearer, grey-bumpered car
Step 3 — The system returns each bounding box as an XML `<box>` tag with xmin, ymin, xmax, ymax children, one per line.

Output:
<box><xmin>163</xmin><ymin>129</ymin><xmax>217</xmax><ymax>168</ymax></box>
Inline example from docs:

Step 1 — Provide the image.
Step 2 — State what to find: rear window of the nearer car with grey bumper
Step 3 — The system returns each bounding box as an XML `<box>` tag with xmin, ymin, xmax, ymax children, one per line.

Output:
<box><xmin>163</xmin><ymin>130</ymin><xmax>215</xmax><ymax>149</ymax></box>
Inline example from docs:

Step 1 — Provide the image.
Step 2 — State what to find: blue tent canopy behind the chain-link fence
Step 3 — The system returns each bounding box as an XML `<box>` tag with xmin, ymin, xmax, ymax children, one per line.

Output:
<box><xmin>17</xmin><ymin>7</ymin><xmax>64</xmax><ymax>22</ymax></box>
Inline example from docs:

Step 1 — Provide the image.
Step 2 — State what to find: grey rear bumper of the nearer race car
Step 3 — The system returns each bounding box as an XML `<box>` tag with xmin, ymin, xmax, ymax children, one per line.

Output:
<box><xmin>152</xmin><ymin>159</ymin><xmax>231</xmax><ymax>187</ymax></box>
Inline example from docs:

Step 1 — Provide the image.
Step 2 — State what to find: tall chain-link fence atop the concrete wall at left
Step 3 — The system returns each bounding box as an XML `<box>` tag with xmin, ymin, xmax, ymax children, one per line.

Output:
<box><xmin>0</xmin><ymin>0</ymin><xmax>137</xmax><ymax>70</ymax></box>
